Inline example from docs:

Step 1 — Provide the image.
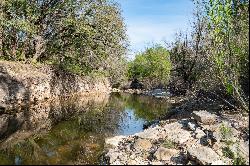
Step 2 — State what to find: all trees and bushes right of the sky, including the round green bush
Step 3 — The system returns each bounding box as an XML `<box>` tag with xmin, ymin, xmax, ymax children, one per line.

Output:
<box><xmin>128</xmin><ymin>0</ymin><xmax>249</xmax><ymax>110</ymax></box>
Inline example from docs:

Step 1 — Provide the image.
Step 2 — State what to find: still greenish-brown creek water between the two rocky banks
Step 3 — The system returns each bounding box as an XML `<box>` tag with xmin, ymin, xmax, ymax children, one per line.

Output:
<box><xmin>0</xmin><ymin>93</ymin><xmax>171</xmax><ymax>165</ymax></box>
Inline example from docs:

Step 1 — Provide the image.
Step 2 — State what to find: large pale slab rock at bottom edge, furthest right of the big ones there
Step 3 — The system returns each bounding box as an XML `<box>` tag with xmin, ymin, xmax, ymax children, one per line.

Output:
<box><xmin>187</xmin><ymin>145</ymin><xmax>220</xmax><ymax>165</ymax></box>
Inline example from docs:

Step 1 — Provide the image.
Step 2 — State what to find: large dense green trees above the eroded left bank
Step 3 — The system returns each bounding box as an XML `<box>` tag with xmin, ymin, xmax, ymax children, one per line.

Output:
<box><xmin>0</xmin><ymin>0</ymin><xmax>127</xmax><ymax>85</ymax></box>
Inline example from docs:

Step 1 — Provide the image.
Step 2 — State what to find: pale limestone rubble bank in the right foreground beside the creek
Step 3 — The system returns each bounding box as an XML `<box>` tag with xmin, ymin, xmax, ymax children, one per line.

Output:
<box><xmin>104</xmin><ymin>110</ymin><xmax>249</xmax><ymax>165</ymax></box>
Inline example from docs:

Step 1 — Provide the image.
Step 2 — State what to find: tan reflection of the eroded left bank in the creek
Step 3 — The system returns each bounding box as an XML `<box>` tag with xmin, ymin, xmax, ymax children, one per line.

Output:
<box><xmin>13</xmin><ymin>94</ymin><xmax>109</xmax><ymax>131</ymax></box>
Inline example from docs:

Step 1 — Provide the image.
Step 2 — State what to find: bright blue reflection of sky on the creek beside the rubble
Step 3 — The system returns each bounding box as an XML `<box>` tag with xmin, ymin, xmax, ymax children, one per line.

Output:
<box><xmin>118</xmin><ymin>108</ymin><xmax>145</xmax><ymax>135</ymax></box>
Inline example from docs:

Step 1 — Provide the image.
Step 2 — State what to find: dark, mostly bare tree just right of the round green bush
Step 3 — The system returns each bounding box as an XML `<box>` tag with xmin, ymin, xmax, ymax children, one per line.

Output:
<box><xmin>170</xmin><ymin>1</ymin><xmax>207</xmax><ymax>90</ymax></box>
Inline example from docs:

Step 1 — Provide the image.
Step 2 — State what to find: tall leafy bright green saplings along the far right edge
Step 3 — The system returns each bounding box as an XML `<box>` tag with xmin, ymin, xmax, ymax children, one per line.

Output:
<box><xmin>206</xmin><ymin>0</ymin><xmax>249</xmax><ymax>110</ymax></box>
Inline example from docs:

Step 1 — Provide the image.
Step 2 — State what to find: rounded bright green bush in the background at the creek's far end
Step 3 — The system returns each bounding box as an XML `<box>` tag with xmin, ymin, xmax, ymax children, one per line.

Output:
<box><xmin>128</xmin><ymin>45</ymin><xmax>171</xmax><ymax>88</ymax></box>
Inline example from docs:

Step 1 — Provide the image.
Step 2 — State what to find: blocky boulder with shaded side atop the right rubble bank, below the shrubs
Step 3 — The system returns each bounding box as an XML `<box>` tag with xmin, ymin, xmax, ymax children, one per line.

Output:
<box><xmin>192</xmin><ymin>110</ymin><xmax>216</xmax><ymax>125</ymax></box>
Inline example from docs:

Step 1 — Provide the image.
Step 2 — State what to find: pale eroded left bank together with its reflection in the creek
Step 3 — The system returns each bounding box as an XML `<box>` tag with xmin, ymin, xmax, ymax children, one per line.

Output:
<box><xmin>0</xmin><ymin>61</ymin><xmax>111</xmax><ymax>140</ymax></box>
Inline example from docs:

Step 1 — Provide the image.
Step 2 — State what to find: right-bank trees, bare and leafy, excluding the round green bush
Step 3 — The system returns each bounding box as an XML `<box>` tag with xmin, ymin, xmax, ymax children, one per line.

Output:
<box><xmin>170</xmin><ymin>0</ymin><xmax>249</xmax><ymax>111</ymax></box>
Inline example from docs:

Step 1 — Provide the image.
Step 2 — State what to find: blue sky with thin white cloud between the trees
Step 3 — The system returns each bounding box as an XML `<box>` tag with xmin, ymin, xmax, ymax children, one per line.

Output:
<box><xmin>115</xmin><ymin>0</ymin><xmax>194</xmax><ymax>58</ymax></box>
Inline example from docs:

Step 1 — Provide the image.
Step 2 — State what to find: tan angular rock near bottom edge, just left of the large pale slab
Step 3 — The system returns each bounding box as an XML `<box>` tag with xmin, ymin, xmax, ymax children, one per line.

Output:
<box><xmin>154</xmin><ymin>147</ymin><xmax>178</xmax><ymax>161</ymax></box>
